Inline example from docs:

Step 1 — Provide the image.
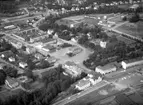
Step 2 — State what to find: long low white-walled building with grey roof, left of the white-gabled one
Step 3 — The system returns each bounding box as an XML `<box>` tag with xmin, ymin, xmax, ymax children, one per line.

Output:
<box><xmin>95</xmin><ymin>64</ymin><xmax>117</xmax><ymax>74</ymax></box>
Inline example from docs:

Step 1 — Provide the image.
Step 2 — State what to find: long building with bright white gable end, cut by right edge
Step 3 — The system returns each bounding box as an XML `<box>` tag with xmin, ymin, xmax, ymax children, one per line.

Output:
<box><xmin>121</xmin><ymin>58</ymin><xmax>143</xmax><ymax>69</ymax></box>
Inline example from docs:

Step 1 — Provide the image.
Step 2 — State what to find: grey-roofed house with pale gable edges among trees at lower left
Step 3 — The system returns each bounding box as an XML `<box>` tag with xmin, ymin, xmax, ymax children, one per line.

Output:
<box><xmin>5</xmin><ymin>77</ymin><xmax>19</xmax><ymax>88</ymax></box>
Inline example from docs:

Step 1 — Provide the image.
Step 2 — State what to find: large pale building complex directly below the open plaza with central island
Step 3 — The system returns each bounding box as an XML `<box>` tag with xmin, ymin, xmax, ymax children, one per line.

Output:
<box><xmin>63</xmin><ymin>61</ymin><xmax>82</xmax><ymax>77</ymax></box>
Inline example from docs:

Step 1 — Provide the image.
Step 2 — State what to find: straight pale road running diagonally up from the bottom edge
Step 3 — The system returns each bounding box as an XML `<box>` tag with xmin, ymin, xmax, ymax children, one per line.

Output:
<box><xmin>53</xmin><ymin>81</ymin><xmax>109</xmax><ymax>105</ymax></box>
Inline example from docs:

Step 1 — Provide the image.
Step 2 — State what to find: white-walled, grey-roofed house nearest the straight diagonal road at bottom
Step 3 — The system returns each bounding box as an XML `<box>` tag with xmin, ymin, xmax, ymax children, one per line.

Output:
<box><xmin>75</xmin><ymin>78</ymin><xmax>90</xmax><ymax>90</ymax></box>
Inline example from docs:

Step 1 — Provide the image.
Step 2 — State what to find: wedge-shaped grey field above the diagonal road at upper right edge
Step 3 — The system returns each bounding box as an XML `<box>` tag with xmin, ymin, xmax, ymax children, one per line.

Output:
<box><xmin>116</xmin><ymin>21</ymin><xmax>143</xmax><ymax>38</ymax></box>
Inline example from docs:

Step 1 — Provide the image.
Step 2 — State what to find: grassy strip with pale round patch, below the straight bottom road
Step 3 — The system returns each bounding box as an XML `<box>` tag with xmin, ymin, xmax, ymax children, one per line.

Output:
<box><xmin>67</xmin><ymin>84</ymin><xmax>124</xmax><ymax>105</ymax></box>
